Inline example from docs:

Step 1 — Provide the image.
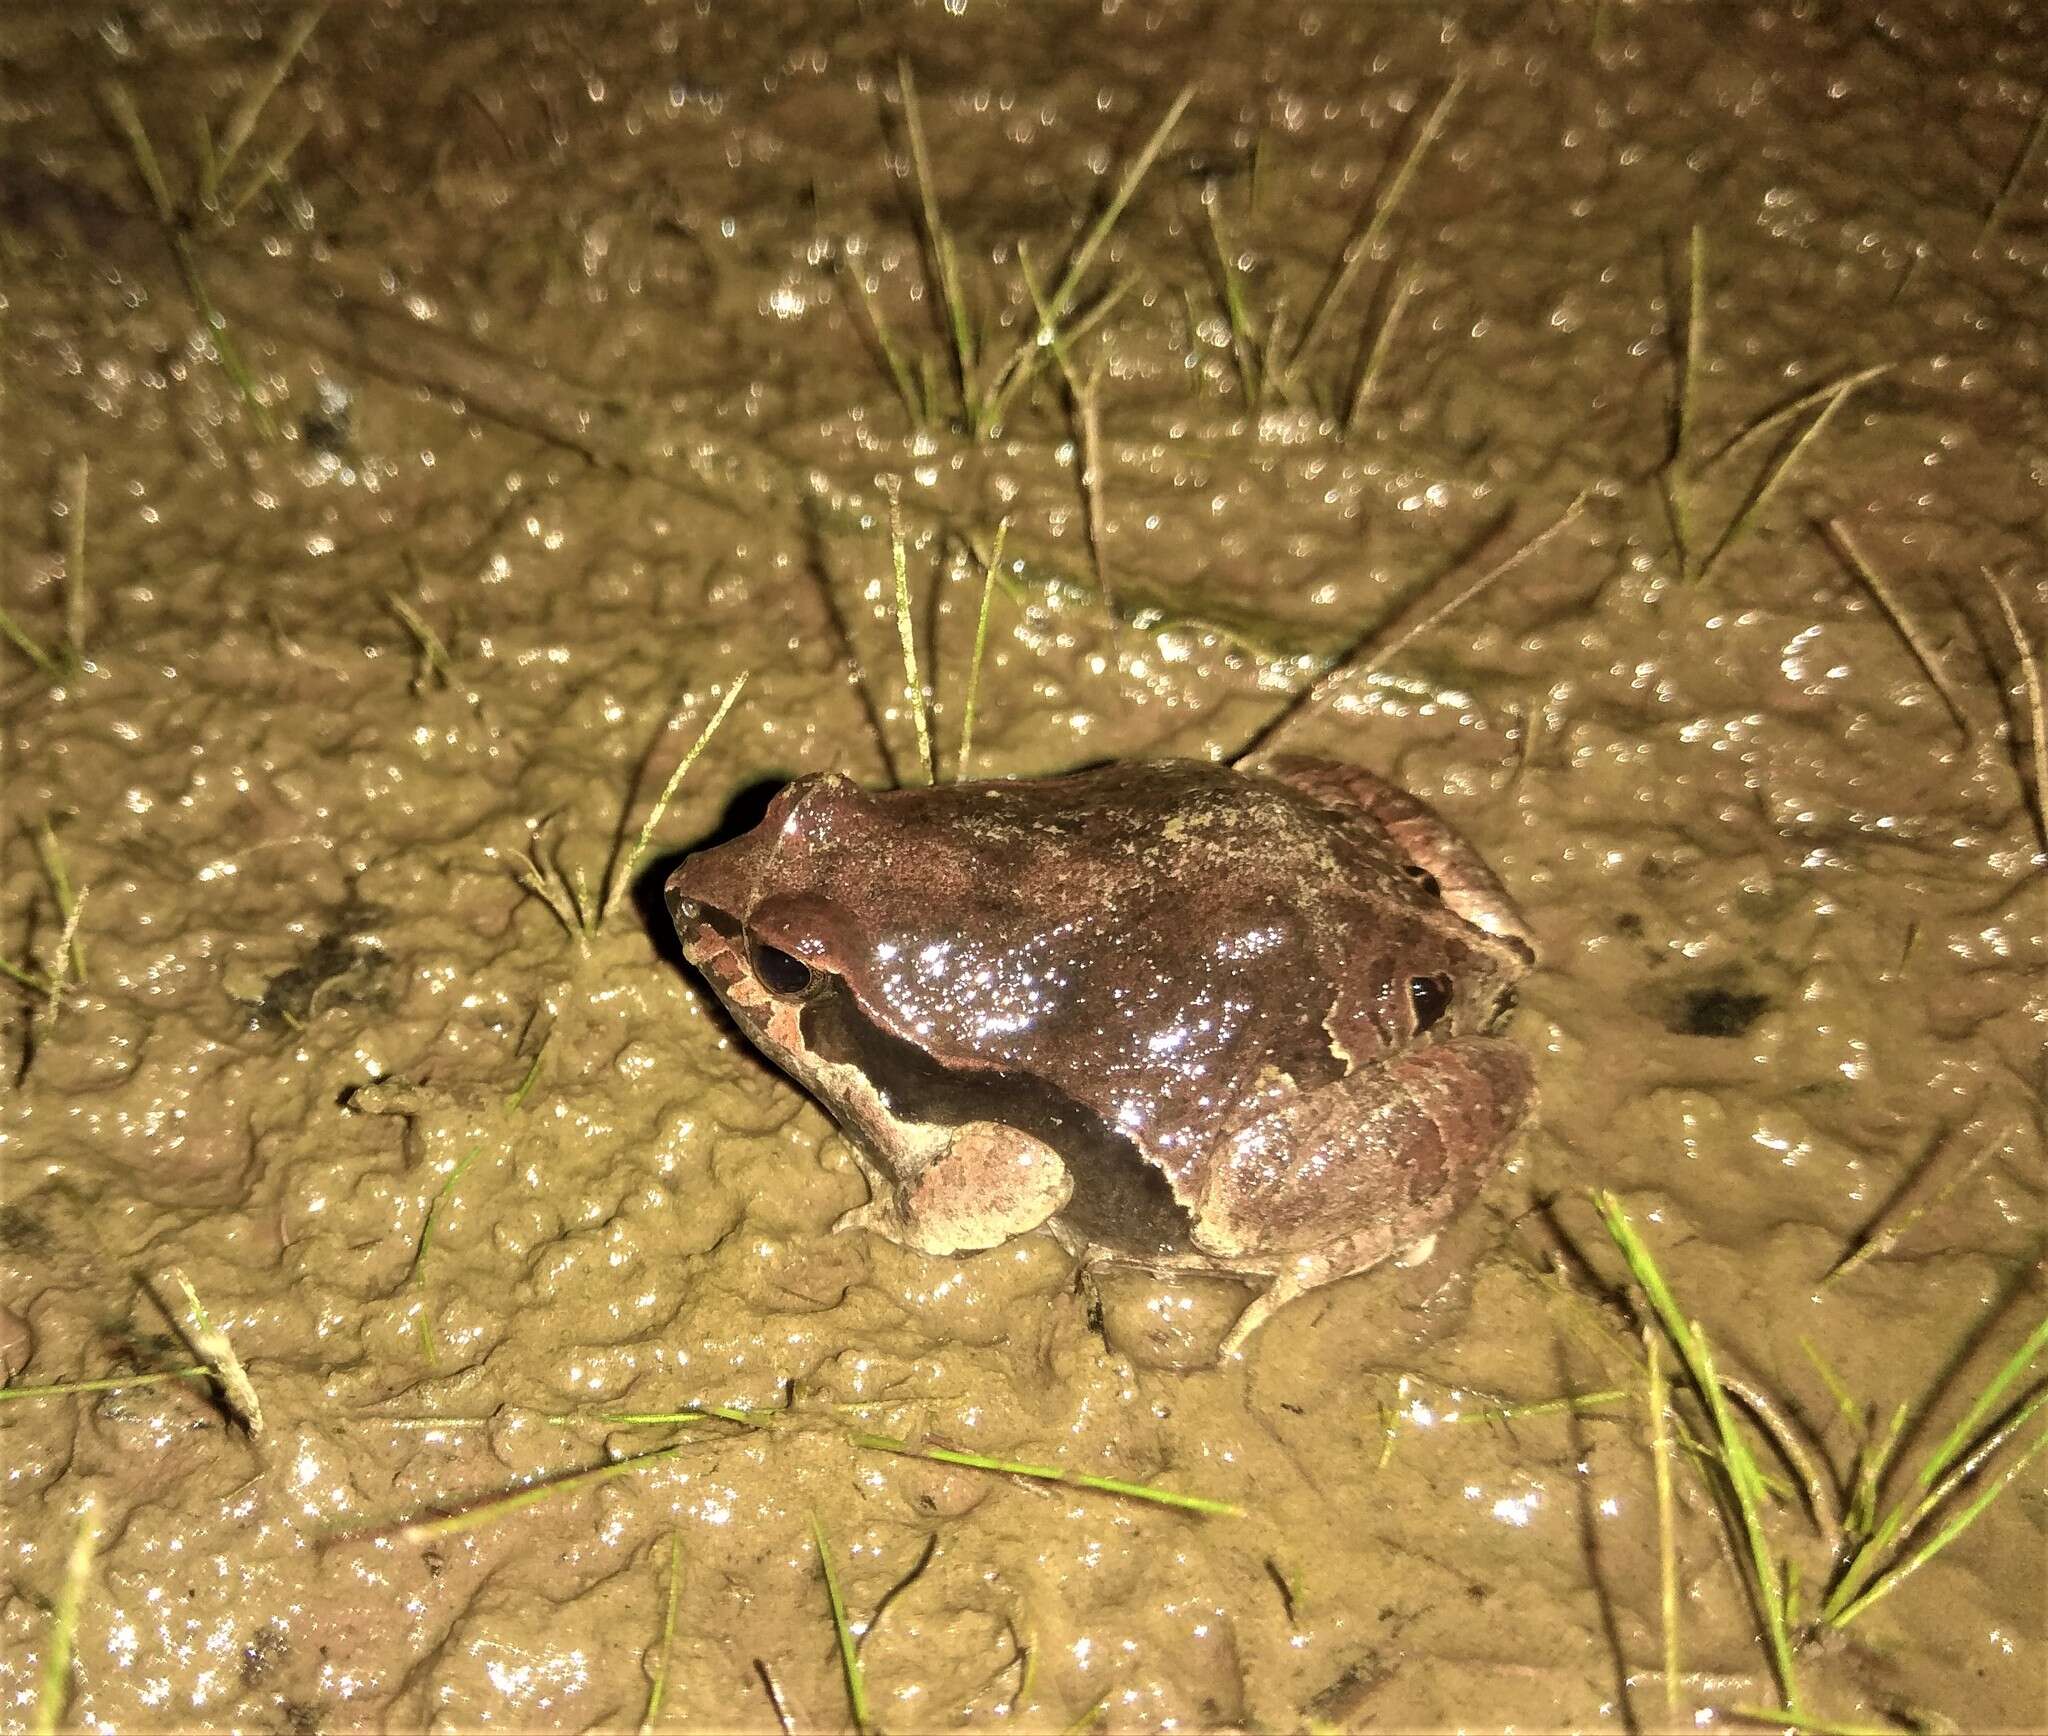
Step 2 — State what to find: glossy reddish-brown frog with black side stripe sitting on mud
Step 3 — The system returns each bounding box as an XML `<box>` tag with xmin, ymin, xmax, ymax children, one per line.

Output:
<box><xmin>668</xmin><ymin>757</ymin><xmax>1536</xmax><ymax>1349</ymax></box>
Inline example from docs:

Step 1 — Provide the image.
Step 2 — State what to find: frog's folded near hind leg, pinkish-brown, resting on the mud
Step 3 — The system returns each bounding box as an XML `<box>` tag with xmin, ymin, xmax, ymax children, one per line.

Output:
<box><xmin>1194</xmin><ymin>1036</ymin><xmax>1534</xmax><ymax>1261</ymax></box>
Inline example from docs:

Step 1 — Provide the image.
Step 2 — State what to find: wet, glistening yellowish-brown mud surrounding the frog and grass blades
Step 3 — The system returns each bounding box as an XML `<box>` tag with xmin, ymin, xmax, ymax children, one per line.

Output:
<box><xmin>0</xmin><ymin>0</ymin><xmax>2048</xmax><ymax>1732</ymax></box>
